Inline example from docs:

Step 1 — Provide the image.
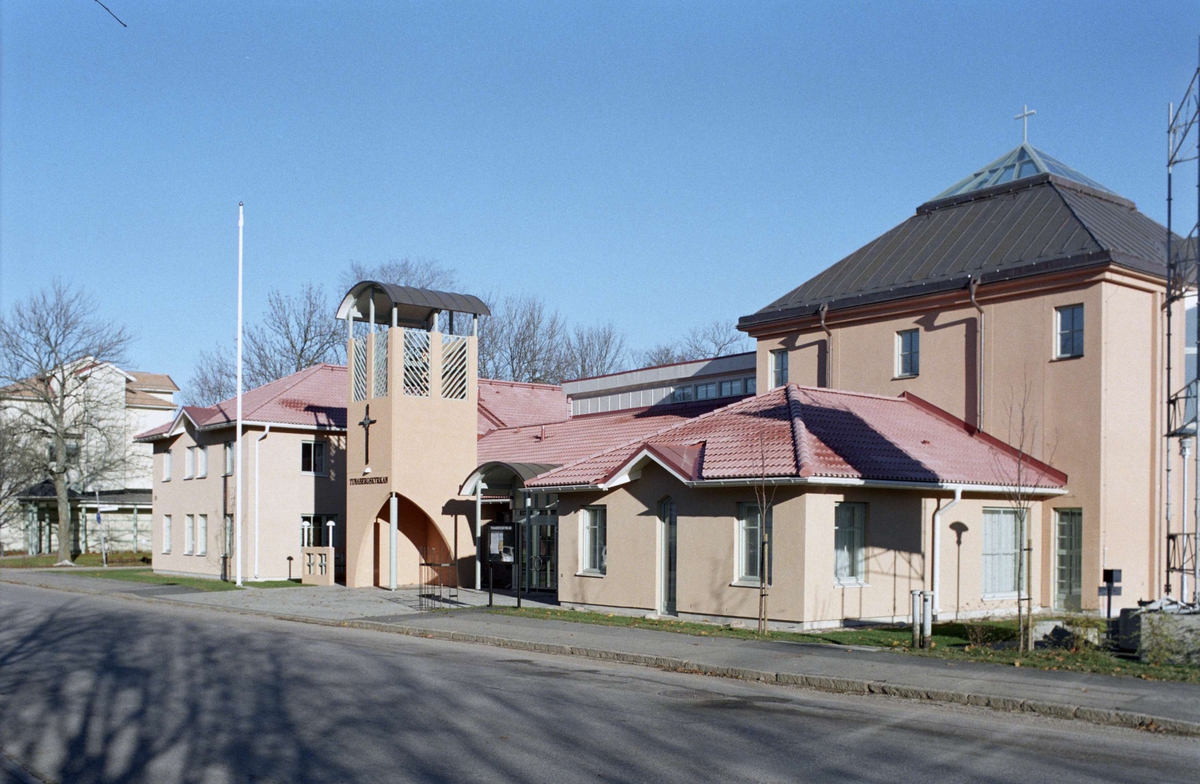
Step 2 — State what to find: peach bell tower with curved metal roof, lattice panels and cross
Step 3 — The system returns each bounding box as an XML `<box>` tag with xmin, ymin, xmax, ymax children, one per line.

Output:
<box><xmin>337</xmin><ymin>281</ymin><xmax>488</xmax><ymax>588</ymax></box>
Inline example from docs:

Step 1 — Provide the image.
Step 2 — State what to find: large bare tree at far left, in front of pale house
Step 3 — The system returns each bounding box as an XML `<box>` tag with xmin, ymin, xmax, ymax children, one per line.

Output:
<box><xmin>0</xmin><ymin>281</ymin><xmax>131</xmax><ymax>564</ymax></box>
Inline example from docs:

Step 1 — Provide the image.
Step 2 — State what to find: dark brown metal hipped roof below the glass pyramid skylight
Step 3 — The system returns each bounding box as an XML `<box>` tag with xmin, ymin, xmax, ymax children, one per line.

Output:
<box><xmin>738</xmin><ymin>174</ymin><xmax>1166</xmax><ymax>328</ymax></box>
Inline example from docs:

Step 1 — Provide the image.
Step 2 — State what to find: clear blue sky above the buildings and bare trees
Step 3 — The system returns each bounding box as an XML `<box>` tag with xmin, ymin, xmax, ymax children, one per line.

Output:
<box><xmin>0</xmin><ymin>0</ymin><xmax>1200</xmax><ymax>384</ymax></box>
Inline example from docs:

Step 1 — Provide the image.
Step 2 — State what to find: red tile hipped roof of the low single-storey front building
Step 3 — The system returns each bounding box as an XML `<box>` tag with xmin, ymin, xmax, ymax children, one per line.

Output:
<box><xmin>520</xmin><ymin>384</ymin><xmax>1067</xmax><ymax>489</ymax></box>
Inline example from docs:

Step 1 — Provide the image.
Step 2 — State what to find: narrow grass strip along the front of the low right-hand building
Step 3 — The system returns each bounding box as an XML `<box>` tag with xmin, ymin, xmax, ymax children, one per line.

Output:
<box><xmin>491</xmin><ymin>608</ymin><xmax>1200</xmax><ymax>683</ymax></box>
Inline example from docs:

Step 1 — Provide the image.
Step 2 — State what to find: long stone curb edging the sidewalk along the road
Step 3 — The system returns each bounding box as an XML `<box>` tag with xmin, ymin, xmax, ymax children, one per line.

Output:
<box><xmin>9</xmin><ymin>577</ymin><xmax>1200</xmax><ymax>737</ymax></box>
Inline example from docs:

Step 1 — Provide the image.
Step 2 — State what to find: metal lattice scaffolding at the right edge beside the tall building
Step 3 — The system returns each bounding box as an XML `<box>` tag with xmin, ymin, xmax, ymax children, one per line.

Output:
<box><xmin>1164</xmin><ymin>53</ymin><xmax>1200</xmax><ymax>604</ymax></box>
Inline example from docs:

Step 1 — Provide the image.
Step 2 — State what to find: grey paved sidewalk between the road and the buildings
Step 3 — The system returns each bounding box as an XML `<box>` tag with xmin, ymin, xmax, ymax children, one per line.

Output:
<box><xmin>9</xmin><ymin>569</ymin><xmax>1200</xmax><ymax>736</ymax></box>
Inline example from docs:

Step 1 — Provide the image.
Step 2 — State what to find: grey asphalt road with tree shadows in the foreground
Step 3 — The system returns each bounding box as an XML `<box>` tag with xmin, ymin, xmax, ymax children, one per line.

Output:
<box><xmin>0</xmin><ymin>585</ymin><xmax>1200</xmax><ymax>784</ymax></box>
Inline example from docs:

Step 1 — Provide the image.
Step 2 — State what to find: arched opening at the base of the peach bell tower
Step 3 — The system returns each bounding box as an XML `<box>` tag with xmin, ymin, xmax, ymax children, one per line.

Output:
<box><xmin>372</xmin><ymin>493</ymin><xmax>455</xmax><ymax>588</ymax></box>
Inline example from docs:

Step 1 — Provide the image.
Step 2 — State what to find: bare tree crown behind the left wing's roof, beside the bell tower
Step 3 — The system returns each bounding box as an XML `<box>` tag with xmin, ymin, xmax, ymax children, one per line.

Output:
<box><xmin>186</xmin><ymin>283</ymin><xmax>346</xmax><ymax>406</ymax></box>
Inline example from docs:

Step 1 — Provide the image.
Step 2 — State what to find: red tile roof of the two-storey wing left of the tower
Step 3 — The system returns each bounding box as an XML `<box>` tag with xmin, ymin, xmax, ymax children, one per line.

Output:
<box><xmin>136</xmin><ymin>364</ymin><xmax>349</xmax><ymax>441</ymax></box>
